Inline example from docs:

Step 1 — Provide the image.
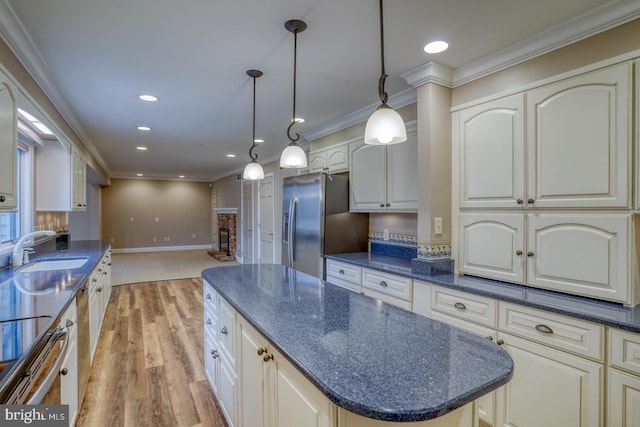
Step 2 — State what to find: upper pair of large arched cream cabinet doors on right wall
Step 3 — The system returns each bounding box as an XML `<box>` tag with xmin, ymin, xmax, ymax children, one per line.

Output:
<box><xmin>458</xmin><ymin>63</ymin><xmax>632</xmax><ymax>208</ymax></box>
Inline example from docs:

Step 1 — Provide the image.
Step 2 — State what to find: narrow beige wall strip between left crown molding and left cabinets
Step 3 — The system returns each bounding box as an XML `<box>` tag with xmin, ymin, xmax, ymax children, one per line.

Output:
<box><xmin>0</xmin><ymin>39</ymin><xmax>109</xmax><ymax>184</ymax></box>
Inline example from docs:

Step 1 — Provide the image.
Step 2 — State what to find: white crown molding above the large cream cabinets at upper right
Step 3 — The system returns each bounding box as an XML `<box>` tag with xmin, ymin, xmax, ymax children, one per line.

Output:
<box><xmin>453</xmin><ymin>0</ymin><xmax>640</xmax><ymax>87</ymax></box>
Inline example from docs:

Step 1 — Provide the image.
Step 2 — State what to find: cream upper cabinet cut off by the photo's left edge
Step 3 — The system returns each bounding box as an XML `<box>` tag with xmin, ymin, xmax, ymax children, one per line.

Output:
<box><xmin>0</xmin><ymin>77</ymin><xmax>18</xmax><ymax>211</ymax></box>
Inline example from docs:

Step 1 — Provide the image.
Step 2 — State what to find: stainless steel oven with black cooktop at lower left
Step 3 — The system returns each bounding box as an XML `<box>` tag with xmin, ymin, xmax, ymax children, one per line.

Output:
<box><xmin>1</xmin><ymin>318</ymin><xmax>69</xmax><ymax>404</ymax></box>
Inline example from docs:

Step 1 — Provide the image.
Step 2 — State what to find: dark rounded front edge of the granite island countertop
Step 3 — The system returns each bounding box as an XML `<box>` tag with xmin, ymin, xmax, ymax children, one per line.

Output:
<box><xmin>202</xmin><ymin>267</ymin><xmax>513</xmax><ymax>422</ymax></box>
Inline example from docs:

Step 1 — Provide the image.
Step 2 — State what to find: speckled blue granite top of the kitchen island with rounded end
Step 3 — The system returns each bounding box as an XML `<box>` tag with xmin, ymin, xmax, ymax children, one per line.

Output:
<box><xmin>202</xmin><ymin>264</ymin><xmax>513</xmax><ymax>422</ymax></box>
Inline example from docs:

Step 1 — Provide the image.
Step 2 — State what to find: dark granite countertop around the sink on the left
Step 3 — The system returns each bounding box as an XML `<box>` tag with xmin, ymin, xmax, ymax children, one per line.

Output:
<box><xmin>0</xmin><ymin>239</ymin><xmax>110</xmax><ymax>400</ymax></box>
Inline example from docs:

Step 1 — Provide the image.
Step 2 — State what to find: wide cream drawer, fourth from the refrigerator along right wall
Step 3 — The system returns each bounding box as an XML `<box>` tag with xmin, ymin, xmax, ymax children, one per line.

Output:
<box><xmin>498</xmin><ymin>302</ymin><xmax>604</xmax><ymax>361</ymax></box>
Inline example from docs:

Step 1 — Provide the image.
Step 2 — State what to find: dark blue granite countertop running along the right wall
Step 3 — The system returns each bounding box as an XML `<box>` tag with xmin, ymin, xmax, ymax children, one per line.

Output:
<box><xmin>325</xmin><ymin>252</ymin><xmax>640</xmax><ymax>333</ymax></box>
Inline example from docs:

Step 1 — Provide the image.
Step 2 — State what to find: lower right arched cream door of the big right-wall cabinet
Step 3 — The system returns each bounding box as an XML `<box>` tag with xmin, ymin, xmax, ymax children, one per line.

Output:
<box><xmin>527</xmin><ymin>214</ymin><xmax>631</xmax><ymax>302</ymax></box>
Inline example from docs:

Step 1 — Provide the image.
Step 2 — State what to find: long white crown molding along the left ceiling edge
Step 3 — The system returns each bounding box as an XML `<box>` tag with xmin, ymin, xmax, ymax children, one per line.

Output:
<box><xmin>0</xmin><ymin>0</ymin><xmax>111</xmax><ymax>175</ymax></box>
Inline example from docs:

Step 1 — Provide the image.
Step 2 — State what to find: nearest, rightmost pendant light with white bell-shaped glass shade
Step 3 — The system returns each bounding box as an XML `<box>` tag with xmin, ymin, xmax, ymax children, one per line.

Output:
<box><xmin>364</xmin><ymin>0</ymin><xmax>407</xmax><ymax>145</ymax></box>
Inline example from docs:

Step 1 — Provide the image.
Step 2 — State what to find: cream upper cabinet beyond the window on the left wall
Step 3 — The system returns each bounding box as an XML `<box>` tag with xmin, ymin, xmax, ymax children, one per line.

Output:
<box><xmin>36</xmin><ymin>142</ymin><xmax>87</xmax><ymax>211</ymax></box>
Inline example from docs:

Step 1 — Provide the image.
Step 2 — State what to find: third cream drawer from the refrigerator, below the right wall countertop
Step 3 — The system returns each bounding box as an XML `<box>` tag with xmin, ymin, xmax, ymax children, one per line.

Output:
<box><xmin>431</xmin><ymin>286</ymin><xmax>497</xmax><ymax>328</ymax></box>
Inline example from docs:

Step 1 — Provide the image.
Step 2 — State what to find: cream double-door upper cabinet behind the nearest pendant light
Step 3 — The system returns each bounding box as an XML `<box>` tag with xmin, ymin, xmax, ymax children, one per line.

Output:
<box><xmin>349</xmin><ymin>124</ymin><xmax>418</xmax><ymax>212</ymax></box>
